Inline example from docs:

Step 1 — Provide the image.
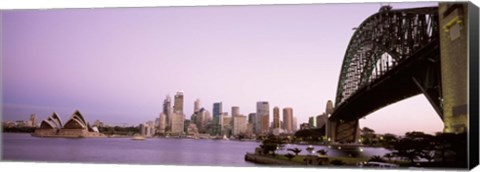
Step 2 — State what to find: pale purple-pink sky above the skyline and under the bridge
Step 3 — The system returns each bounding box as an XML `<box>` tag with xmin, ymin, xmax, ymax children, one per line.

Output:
<box><xmin>1</xmin><ymin>3</ymin><xmax>443</xmax><ymax>134</ymax></box>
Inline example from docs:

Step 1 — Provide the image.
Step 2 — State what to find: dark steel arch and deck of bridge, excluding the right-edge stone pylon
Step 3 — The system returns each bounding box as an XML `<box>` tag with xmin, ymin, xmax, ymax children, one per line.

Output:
<box><xmin>327</xmin><ymin>6</ymin><xmax>443</xmax><ymax>142</ymax></box>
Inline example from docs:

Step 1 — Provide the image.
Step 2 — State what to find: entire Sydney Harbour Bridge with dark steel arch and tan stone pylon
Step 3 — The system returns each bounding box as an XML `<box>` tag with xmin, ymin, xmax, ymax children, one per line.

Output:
<box><xmin>326</xmin><ymin>3</ymin><xmax>470</xmax><ymax>143</ymax></box>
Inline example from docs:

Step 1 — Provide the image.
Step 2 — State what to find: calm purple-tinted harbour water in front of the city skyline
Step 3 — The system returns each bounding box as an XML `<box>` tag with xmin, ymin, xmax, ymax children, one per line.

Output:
<box><xmin>2</xmin><ymin>133</ymin><xmax>388</xmax><ymax>166</ymax></box>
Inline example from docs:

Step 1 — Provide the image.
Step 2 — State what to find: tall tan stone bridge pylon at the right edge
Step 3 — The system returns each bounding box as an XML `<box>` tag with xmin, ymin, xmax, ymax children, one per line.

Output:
<box><xmin>438</xmin><ymin>3</ymin><xmax>468</xmax><ymax>133</ymax></box>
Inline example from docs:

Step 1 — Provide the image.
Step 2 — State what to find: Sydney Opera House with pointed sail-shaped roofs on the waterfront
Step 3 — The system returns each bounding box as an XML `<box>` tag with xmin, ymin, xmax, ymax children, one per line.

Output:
<box><xmin>32</xmin><ymin>110</ymin><xmax>105</xmax><ymax>137</ymax></box>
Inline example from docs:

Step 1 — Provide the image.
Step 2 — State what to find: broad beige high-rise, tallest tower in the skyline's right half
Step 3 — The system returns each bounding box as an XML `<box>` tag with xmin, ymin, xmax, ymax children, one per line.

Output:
<box><xmin>254</xmin><ymin>101</ymin><xmax>270</xmax><ymax>134</ymax></box>
